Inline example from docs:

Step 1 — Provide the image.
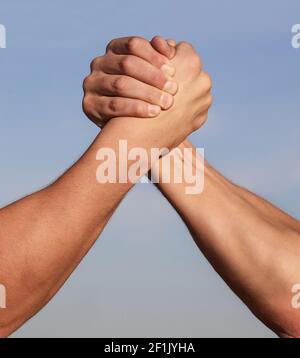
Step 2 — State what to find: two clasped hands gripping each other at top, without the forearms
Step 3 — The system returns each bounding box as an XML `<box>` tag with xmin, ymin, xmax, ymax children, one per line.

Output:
<box><xmin>83</xmin><ymin>36</ymin><xmax>212</xmax><ymax>148</ymax></box>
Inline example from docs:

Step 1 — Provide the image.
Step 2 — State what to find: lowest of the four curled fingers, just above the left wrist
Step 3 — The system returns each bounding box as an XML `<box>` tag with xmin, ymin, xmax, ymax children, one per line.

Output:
<box><xmin>86</xmin><ymin>96</ymin><xmax>161</xmax><ymax>118</ymax></box>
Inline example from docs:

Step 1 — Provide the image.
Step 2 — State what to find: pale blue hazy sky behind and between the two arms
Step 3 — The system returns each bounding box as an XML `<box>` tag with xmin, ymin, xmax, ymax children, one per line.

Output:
<box><xmin>0</xmin><ymin>0</ymin><xmax>300</xmax><ymax>337</ymax></box>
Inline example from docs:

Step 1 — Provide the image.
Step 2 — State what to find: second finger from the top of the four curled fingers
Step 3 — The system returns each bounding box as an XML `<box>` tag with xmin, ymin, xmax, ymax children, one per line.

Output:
<box><xmin>102</xmin><ymin>55</ymin><xmax>178</xmax><ymax>94</ymax></box>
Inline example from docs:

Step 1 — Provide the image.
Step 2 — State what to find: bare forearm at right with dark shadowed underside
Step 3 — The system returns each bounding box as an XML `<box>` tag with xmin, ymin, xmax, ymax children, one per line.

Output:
<box><xmin>154</xmin><ymin>143</ymin><xmax>300</xmax><ymax>336</ymax></box>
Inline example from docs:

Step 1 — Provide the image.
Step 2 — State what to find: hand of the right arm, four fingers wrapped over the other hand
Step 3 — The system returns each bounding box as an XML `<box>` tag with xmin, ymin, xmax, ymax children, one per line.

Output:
<box><xmin>83</xmin><ymin>37</ymin><xmax>177</xmax><ymax>127</ymax></box>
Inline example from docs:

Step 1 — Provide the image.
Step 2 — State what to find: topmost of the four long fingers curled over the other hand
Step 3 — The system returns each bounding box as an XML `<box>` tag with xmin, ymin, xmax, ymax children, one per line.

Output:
<box><xmin>107</xmin><ymin>37</ymin><xmax>174</xmax><ymax>72</ymax></box>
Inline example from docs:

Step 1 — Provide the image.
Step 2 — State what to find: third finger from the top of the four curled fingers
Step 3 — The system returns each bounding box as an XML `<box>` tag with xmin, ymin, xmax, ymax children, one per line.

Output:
<box><xmin>90</xmin><ymin>75</ymin><xmax>174</xmax><ymax>109</ymax></box>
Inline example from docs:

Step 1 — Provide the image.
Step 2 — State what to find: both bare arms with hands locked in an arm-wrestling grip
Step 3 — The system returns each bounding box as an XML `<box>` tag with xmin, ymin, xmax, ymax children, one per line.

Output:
<box><xmin>0</xmin><ymin>37</ymin><xmax>300</xmax><ymax>337</ymax></box>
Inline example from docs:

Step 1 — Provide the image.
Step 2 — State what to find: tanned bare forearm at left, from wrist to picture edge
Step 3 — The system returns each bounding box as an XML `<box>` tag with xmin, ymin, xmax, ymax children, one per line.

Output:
<box><xmin>0</xmin><ymin>118</ymin><xmax>166</xmax><ymax>336</ymax></box>
